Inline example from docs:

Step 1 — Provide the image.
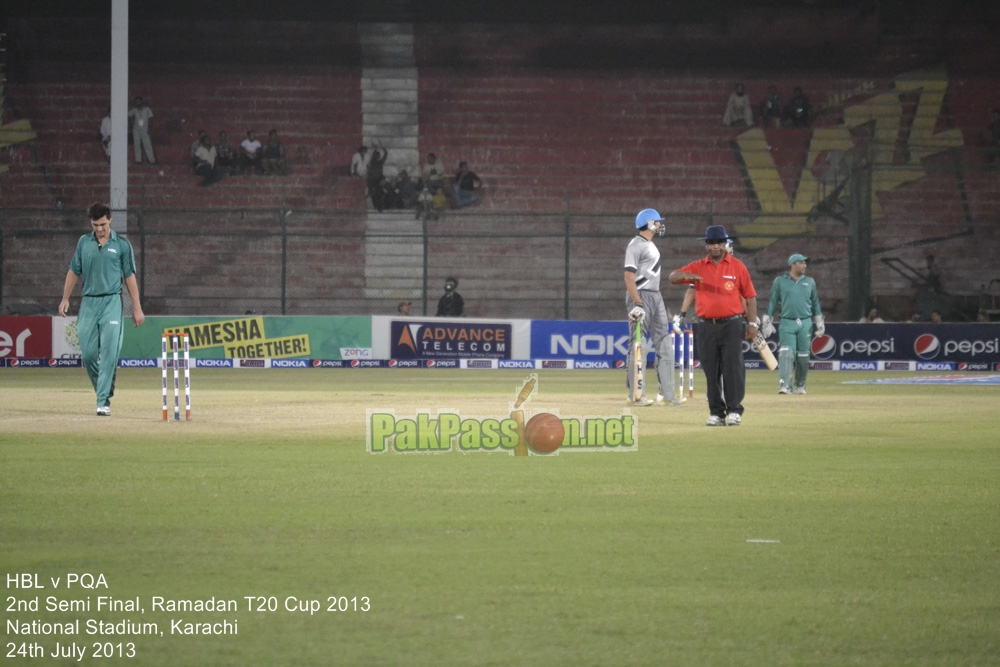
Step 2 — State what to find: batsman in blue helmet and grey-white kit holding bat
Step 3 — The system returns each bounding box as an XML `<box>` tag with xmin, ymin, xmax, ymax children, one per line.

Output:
<box><xmin>625</xmin><ymin>208</ymin><xmax>687</xmax><ymax>407</ymax></box>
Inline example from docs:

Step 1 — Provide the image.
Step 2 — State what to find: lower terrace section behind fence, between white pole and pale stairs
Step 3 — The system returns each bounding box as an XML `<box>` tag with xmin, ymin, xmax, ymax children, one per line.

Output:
<box><xmin>130</xmin><ymin>210</ymin><xmax>365</xmax><ymax>315</ymax></box>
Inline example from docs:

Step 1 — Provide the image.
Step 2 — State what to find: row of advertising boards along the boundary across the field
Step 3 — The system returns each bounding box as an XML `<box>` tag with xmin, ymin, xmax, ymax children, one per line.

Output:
<box><xmin>0</xmin><ymin>315</ymin><xmax>1000</xmax><ymax>371</ymax></box>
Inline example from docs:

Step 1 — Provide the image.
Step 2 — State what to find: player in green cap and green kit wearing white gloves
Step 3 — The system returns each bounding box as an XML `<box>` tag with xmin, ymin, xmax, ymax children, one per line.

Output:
<box><xmin>760</xmin><ymin>253</ymin><xmax>826</xmax><ymax>394</ymax></box>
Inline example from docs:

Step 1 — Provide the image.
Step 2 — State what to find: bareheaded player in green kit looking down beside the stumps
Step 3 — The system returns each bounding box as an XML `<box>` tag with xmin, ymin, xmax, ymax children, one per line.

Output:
<box><xmin>59</xmin><ymin>204</ymin><xmax>146</xmax><ymax>417</ymax></box>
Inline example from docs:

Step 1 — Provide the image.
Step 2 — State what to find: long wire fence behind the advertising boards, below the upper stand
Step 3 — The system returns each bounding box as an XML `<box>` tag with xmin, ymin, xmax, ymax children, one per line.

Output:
<box><xmin>0</xmin><ymin>154</ymin><xmax>1000</xmax><ymax>321</ymax></box>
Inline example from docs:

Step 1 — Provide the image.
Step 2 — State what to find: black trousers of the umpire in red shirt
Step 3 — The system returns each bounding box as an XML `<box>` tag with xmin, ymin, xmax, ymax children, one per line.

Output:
<box><xmin>694</xmin><ymin>317</ymin><xmax>746</xmax><ymax>417</ymax></box>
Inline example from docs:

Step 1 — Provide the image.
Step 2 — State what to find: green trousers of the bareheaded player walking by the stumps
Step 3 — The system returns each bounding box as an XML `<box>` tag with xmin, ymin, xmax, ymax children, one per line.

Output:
<box><xmin>76</xmin><ymin>294</ymin><xmax>125</xmax><ymax>407</ymax></box>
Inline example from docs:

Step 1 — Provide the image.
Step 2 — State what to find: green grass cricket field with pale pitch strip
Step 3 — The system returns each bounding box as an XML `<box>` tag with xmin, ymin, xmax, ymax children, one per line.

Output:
<box><xmin>0</xmin><ymin>368</ymin><xmax>1000</xmax><ymax>666</ymax></box>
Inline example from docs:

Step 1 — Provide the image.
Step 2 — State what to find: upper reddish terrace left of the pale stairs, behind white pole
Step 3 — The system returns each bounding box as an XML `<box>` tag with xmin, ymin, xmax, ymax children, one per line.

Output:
<box><xmin>5</xmin><ymin>64</ymin><xmax>364</xmax><ymax>209</ymax></box>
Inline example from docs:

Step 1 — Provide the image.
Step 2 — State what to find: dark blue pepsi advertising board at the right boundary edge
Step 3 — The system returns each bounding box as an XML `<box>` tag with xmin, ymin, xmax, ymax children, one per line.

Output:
<box><xmin>752</xmin><ymin>323</ymin><xmax>1000</xmax><ymax>370</ymax></box>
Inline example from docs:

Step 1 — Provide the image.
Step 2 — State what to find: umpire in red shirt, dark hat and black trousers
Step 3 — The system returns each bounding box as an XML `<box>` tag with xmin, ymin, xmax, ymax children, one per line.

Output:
<box><xmin>670</xmin><ymin>225</ymin><xmax>760</xmax><ymax>426</ymax></box>
